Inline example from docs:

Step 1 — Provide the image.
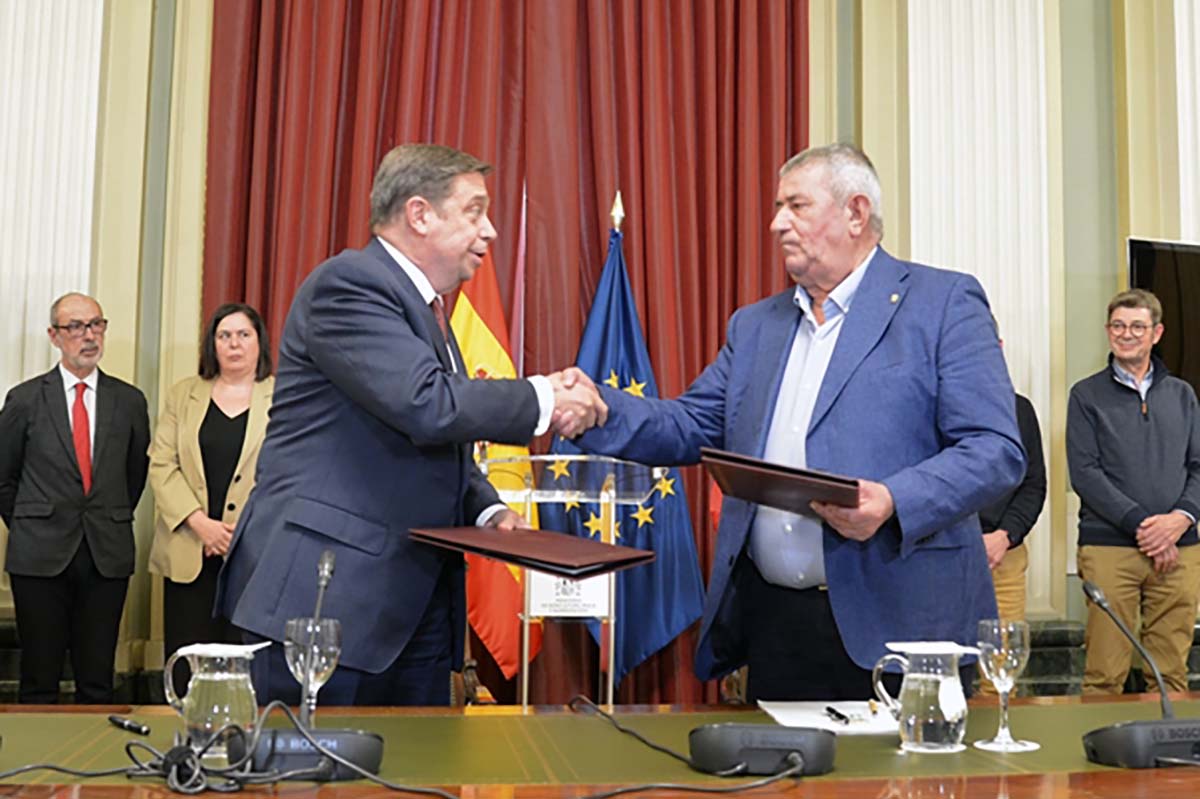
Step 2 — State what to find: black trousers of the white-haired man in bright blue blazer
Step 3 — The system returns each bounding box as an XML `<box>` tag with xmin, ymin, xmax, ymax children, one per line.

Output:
<box><xmin>737</xmin><ymin>555</ymin><xmax>976</xmax><ymax>702</ymax></box>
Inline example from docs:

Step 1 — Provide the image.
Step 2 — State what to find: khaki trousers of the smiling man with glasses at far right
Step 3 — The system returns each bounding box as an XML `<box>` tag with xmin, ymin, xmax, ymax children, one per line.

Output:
<box><xmin>1078</xmin><ymin>546</ymin><xmax>1200</xmax><ymax>693</ymax></box>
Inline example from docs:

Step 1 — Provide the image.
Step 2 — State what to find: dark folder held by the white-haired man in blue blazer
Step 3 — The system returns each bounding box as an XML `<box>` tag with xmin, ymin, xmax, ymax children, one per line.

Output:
<box><xmin>700</xmin><ymin>447</ymin><xmax>858</xmax><ymax>513</ymax></box>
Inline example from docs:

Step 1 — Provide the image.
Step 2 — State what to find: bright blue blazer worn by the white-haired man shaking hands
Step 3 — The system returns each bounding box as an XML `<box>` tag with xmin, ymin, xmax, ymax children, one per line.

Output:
<box><xmin>580</xmin><ymin>248</ymin><xmax>1025</xmax><ymax>679</ymax></box>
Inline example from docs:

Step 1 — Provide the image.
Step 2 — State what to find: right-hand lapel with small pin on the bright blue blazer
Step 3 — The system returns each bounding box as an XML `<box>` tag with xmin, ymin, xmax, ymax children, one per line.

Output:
<box><xmin>809</xmin><ymin>247</ymin><xmax>908</xmax><ymax>433</ymax></box>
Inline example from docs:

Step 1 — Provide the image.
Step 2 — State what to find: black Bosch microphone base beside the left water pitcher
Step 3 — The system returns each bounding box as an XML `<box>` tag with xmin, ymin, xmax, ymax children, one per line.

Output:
<box><xmin>228</xmin><ymin>729</ymin><xmax>383</xmax><ymax>782</ymax></box>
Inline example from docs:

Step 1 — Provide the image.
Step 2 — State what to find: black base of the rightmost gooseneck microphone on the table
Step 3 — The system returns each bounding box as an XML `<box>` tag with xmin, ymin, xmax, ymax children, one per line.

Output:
<box><xmin>1084</xmin><ymin>719</ymin><xmax>1200</xmax><ymax>769</ymax></box>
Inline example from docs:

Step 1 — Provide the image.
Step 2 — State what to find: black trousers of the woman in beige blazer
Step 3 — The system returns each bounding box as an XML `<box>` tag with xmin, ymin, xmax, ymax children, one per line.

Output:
<box><xmin>162</xmin><ymin>555</ymin><xmax>241</xmax><ymax>696</ymax></box>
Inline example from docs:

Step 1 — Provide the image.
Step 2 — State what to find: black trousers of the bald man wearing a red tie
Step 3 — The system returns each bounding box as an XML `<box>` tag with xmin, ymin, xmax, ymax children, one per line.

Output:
<box><xmin>10</xmin><ymin>539</ymin><xmax>128</xmax><ymax>704</ymax></box>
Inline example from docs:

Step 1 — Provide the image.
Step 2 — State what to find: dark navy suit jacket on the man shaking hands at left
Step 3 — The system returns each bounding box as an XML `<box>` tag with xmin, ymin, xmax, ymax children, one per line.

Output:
<box><xmin>217</xmin><ymin>240</ymin><xmax>538</xmax><ymax>673</ymax></box>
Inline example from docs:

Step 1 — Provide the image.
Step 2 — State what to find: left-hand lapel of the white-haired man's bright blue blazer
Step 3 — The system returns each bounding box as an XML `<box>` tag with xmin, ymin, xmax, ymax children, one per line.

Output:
<box><xmin>730</xmin><ymin>289</ymin><xmax>802</xmax><ymax>456</ymax></box>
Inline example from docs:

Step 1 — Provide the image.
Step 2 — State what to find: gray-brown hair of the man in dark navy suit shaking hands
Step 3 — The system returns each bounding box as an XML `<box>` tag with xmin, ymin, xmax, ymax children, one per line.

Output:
<box><xmin>371</xmin><ymin>144</ymin><xmax>492</xmax><ymax>230</ymax></box>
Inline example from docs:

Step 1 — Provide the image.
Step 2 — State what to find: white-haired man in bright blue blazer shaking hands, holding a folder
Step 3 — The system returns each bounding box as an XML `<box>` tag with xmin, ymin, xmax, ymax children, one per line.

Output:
<box><xmin>578</xmin><ymin>144</ymin><xmax>1025</xmax><ymax>699</ymax></box>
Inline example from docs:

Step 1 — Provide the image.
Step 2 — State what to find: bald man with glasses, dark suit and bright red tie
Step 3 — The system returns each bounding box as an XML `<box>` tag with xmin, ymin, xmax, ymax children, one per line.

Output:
<box><xmin>0</xmin><ymin>294</ymin><xmax>150</xmax><ymax>704</ymax></box>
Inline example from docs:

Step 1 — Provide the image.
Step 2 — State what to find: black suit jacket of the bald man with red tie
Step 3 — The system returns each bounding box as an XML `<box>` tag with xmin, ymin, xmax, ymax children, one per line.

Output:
<box><xmin>0</xmin><ymin>366</ymin><xmax>150</xmax><ymax>577</ymax></box>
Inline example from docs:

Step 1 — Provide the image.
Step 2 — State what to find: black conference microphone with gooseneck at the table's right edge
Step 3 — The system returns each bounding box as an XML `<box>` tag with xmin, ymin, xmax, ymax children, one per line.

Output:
<box><xmin>1084</xmin><ymin>579</ymin><xmax>1200</xmax><ymax>769</ymax></box>
